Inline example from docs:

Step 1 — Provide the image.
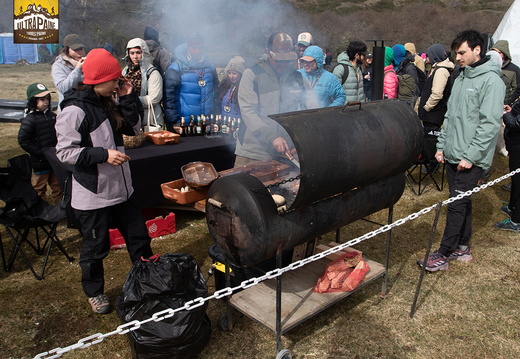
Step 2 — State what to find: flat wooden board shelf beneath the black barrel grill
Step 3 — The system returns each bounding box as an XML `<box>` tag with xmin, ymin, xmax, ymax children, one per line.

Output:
<box><xmin>230</xmin><ymin>245</ymin><xmax>385</xmax><ymax>333</ymax></box>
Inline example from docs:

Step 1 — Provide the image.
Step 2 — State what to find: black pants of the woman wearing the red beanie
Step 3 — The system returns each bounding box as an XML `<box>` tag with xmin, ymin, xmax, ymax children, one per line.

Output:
<box><xmin>74</xmin><ymin>196</ymin><xmax>152</xmax><ymax>297</ymax></box>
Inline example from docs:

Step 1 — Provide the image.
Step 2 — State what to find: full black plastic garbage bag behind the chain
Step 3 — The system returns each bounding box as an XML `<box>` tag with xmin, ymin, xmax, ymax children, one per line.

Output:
<box><xmin>116</xmin><ymin>253</ymin><xmax>211</xmax><ymax>359</ymax></box>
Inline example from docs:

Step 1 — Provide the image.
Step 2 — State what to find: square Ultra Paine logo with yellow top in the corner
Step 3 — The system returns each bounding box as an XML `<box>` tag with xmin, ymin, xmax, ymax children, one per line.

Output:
<box><xmin>13</xmin><ymin>0</ymin><xmax>59</xmax><ymax>44</ymax></box>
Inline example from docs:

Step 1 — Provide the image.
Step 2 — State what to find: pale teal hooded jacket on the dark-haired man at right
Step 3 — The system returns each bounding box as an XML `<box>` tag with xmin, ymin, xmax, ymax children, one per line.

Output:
<box><xmin>437</xmin><ymin>56</ymin><xmax>505</xmax><ymax>170</ymax></box>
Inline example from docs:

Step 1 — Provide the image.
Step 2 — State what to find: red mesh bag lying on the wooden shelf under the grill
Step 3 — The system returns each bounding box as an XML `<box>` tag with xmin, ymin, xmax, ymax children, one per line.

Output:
<box><xmin>313</xmin><ymin>252</ymin><xmax>370</xmax><ymax>293</ymax></box>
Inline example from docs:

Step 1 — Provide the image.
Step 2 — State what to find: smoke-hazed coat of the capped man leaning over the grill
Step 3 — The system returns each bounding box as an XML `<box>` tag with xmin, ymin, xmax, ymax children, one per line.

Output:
<box><xmin>235</xmin><ymin>57</ymin><xmax>305</xmax><ymax>161</ymax></box>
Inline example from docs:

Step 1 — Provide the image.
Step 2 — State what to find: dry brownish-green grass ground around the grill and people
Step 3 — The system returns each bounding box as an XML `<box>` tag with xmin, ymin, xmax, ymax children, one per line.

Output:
<box><xmin>0</xmin><ymin>65</ymin><xmax>520</xmax><ymax>359</ymax></box>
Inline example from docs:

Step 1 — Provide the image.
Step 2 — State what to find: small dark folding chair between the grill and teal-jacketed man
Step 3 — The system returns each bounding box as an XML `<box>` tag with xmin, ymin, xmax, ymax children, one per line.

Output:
<box><xmin>406</xmin><ymin>158</ymin><xmax>446</xmax><ymax>196</ymax></box>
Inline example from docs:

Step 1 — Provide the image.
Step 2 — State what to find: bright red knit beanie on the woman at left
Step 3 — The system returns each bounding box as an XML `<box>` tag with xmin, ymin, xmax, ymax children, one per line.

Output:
<box><xmin>83</xmin><ymin>49</ymin><xmax>121</xmax><ymax>85</ymax></box>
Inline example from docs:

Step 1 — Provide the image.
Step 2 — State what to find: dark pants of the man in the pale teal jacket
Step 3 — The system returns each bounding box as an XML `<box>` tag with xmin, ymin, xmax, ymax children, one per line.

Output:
<box><xmin>439</xmin><ymin>163</ymin><xmax>484</xmax><ymax>256</ymax></box>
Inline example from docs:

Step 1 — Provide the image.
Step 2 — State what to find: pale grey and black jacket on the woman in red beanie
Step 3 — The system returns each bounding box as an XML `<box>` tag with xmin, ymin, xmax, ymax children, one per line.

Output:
<box><xmin>56</xmin><ymin>89</ymin><xmax>141</xmax><ymax>210</ymax></box>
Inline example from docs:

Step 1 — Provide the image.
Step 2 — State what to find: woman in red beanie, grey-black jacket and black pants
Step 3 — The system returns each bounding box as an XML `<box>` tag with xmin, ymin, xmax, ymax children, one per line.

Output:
<box><xmin>56</xmin><ymin>49</ymin><xmax>152</xmax><ymax>314</ymax></box>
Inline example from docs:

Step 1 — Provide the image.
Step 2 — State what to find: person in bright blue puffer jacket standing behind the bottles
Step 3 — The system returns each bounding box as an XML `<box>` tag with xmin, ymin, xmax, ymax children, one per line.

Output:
<box><xmin>164</xmin><ymin>33</ymin><xmax>218</xmax><ymax>131</ymax></box>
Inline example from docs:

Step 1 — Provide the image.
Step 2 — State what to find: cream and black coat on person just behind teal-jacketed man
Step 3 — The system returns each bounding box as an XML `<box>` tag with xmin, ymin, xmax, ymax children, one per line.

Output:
<box><xmin>418</xmin><ymin>59</ymin><xmax>455</xmax><ymax>126</ymax></box>
